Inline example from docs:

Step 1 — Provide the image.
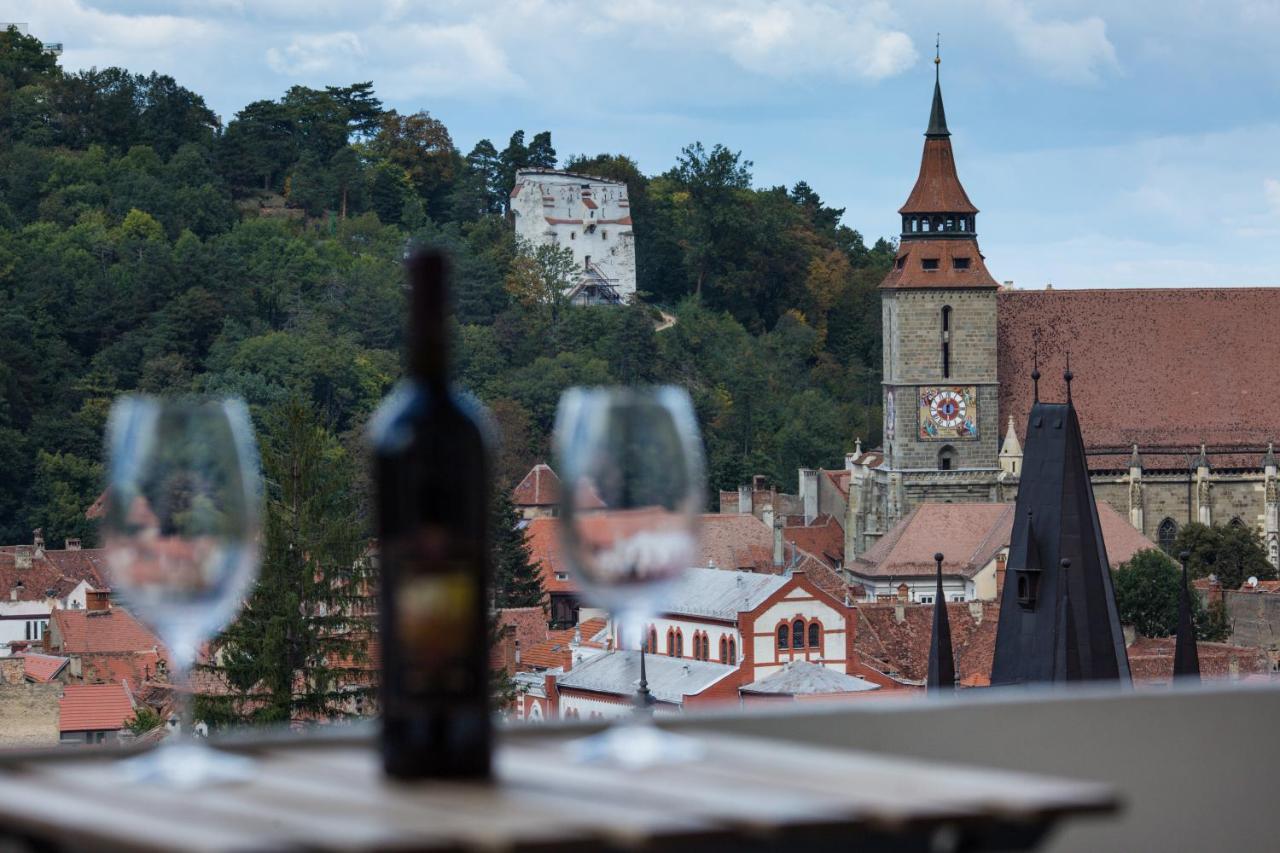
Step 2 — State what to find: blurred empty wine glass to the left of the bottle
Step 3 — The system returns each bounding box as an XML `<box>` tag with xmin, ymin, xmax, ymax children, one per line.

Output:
<box><xmin>102</xmin><ymin>396</ymin><xmax>261</xmax><ymax>788</ymax></box>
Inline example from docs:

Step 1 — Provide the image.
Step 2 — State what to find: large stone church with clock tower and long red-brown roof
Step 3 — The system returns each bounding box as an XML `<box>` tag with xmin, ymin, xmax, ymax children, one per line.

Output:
<box><xmin>849</xmin><ymin>59</ymin><xmax>1280</xmax><ymax>566</ymax></box>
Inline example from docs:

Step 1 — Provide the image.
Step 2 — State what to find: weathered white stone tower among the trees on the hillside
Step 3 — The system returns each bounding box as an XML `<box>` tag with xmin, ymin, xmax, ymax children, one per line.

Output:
<box><xmin>511</xmin><ymin>169</ymin><xmax>636</xmax><ymax>305</ymax></box>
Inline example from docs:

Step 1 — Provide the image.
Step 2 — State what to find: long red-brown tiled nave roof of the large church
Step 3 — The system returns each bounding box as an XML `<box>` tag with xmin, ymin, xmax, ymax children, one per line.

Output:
<box><xmin>997</xmin><ymin>287</ymin><xmax>1280</xmax><ymax>450</ymax></box>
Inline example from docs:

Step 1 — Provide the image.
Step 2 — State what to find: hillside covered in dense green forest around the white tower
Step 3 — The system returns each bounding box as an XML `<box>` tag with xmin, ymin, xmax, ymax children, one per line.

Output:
<box><xmin>0</xmin><ymin>31</ymin><xmax>892</xmax><ymax>544</ymax></box>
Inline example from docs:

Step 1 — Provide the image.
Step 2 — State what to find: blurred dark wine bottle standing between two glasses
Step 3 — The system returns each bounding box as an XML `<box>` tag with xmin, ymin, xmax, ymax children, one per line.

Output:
<box><xmin>370</xmin><ymin>247</ymin><xmax>493</xmax><ymax>779</ymax></box>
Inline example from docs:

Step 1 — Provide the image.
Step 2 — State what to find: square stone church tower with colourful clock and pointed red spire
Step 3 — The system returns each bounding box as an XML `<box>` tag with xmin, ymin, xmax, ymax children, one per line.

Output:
<box><xmin>881</xmin><ymin>52</ymin><xmax>1000</xmax><ymax>471</ymax></box>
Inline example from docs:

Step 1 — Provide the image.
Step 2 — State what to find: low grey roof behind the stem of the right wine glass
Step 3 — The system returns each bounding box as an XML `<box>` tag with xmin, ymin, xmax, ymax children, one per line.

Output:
<box><xmin>558</xmin><ymin>651</ymin><xmax>737</xmax><ymax>703</ymax></box>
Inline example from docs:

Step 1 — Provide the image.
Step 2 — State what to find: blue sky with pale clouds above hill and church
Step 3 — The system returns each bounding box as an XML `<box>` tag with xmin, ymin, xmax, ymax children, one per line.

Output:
<box><xmin>10</xmin><ymin>0</ymin><xmax>1280</xmax><ymax>288</ymax></box>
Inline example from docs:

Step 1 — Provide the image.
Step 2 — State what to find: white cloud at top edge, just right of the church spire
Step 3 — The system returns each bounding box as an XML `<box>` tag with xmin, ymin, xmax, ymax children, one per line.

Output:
<box><xmin>988</xmin><ymin>0</ymin><xmax>1119</xmax><ymax>83</ymax></box>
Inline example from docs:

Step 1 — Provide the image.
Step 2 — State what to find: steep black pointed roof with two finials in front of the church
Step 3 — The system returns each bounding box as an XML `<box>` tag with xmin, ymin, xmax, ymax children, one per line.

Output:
<box><xmin>991</xmin><ymin>370</ymin><xmax>1129</xmax><ymax>686</ymax></box>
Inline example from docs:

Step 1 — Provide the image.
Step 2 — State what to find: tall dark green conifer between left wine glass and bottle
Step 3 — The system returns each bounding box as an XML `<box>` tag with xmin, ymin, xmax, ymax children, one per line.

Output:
<box><xmin>197</xmin><ymin>398</ymin><xmax>372</xmax><ymax>722</ymax></box>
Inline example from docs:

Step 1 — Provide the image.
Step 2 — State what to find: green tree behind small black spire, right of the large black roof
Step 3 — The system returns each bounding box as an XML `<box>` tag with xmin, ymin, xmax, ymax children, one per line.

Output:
<box><xmin>1114</xmin><ymin>548</ymin><xmax>1229</xmax><ymax>642</ymax></box>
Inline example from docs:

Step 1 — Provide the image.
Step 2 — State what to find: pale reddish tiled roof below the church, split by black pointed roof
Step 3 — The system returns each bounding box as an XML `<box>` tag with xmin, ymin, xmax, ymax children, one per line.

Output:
<box><xmin>849</xmin><ymin>501</ymin><xmax>1156</xmax><ymax>578</ymax></box>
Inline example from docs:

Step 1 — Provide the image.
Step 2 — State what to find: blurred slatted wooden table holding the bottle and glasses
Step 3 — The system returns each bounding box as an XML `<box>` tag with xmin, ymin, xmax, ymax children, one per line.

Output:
<box><xmin>0</xmin><ymin>733</ymin><xmax>1116</xmax><ymax>852</ymax></box>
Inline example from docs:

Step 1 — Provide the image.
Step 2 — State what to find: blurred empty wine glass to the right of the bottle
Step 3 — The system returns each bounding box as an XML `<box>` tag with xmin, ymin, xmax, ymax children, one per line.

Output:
<box><xmin>554</xmin><ymin>386</ymin><xmax>704</xmax><ymax>767</ymax></box>
